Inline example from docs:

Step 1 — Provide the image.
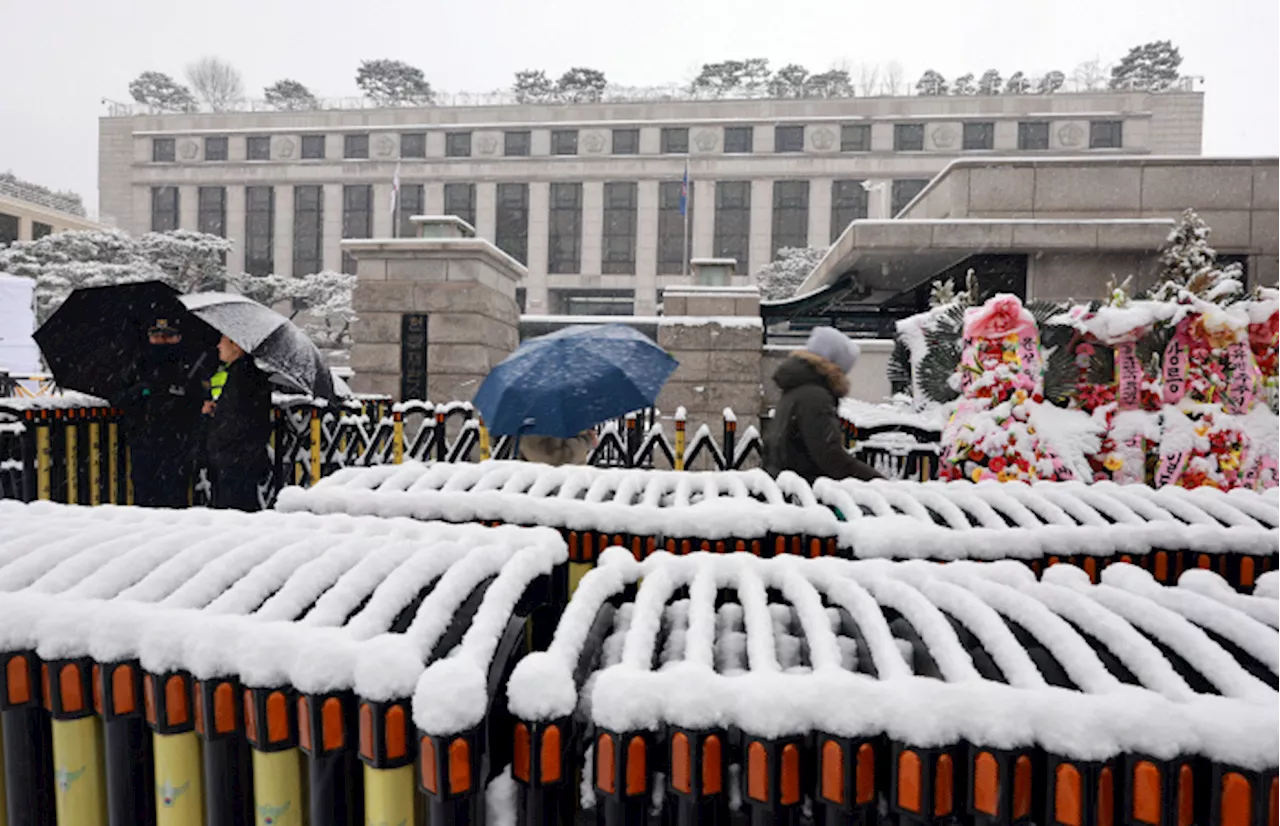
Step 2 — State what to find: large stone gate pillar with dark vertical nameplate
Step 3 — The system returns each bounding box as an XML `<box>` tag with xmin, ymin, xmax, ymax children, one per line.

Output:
<box><xmin>342</xmin><ymin>215</ymin><xmax>527</xmax><ymax>402</ymax></box>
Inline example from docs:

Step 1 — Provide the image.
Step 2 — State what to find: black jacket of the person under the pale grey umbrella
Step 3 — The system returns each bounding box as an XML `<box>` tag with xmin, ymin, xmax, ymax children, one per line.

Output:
<box><xmin>209</xmin><ymin>355</ymin><xmax>271</xmax><ymax>470</ymax></box>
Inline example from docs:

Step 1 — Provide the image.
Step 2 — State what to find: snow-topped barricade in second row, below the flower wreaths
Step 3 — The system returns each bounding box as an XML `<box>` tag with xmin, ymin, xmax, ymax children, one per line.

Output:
<box><xmin>813</xmin><ymin>479</ymin><xmax>1280</xmax><ymax>592</ymax></box>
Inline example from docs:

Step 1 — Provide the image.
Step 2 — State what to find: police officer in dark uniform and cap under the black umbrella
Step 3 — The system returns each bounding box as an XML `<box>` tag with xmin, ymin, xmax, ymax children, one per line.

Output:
<box><xmin>113</xmin><ymin>319</ymin><xmax>209</xmax><ymax>507</ymax></box>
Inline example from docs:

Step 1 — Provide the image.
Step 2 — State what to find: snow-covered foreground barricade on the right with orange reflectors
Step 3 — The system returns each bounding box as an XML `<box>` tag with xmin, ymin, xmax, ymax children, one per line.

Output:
<box><xmin>508</xmin><ymin>548</ymin><xmax>1280</xmax><ymax>826</ymax></box>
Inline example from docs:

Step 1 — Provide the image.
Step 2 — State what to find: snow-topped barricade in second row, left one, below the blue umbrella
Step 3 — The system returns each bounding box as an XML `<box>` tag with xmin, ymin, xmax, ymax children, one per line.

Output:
<box><xmin>276</xmin><ymin>461</ymin><xmax>838</xmax><ymax>562</ymax></box>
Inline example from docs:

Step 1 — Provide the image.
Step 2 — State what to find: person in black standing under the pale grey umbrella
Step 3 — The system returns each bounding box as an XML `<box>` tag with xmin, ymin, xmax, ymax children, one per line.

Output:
<box><xmin>206</xmin><ymin>336</ymin><xmax>271</xmax><ymax>511</ymax></box>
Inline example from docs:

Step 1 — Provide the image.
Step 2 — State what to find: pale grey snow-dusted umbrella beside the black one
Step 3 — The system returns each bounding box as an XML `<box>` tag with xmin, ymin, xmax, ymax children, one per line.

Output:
<box><xmin>182</xmin><ymin>292</ymin><xmax>337</xmax><ymax>398</ymax></box>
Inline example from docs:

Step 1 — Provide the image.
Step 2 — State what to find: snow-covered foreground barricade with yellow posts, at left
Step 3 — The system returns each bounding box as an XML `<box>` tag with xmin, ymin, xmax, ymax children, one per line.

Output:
<box><xmin>0</xmin><ymin>502</ymin><xmax>566</xmax><ymax>826</ymax></box>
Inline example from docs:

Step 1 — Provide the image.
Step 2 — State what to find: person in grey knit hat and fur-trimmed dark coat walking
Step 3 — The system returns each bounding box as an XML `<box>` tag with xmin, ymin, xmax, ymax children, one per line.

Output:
<box><xmin>764</xmin><ymin>327</ymin><xmax>881</xmax><ymax>483</ymax></box>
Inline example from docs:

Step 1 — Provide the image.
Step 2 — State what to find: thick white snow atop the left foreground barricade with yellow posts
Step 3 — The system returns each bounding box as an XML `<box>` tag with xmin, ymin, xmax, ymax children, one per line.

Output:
<box><xmin>0</xmin><ymin>501</ymin><xmax>567</xmax><ymax>722</ymax></box>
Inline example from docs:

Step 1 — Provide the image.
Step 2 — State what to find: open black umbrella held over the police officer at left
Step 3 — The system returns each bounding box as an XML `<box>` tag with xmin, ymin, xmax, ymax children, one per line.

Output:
<box><xmin>35</xmin><ymin>280</ymin><xmax>218</xmax><ymax>400</ymax></box>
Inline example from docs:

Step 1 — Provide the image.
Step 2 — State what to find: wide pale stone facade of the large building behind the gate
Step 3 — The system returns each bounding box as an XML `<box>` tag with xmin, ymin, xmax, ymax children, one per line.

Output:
<box><xmin>99</xmin><ymin>91</ymin><xmax>1203</xmax><ymax>315</ymax></box>
